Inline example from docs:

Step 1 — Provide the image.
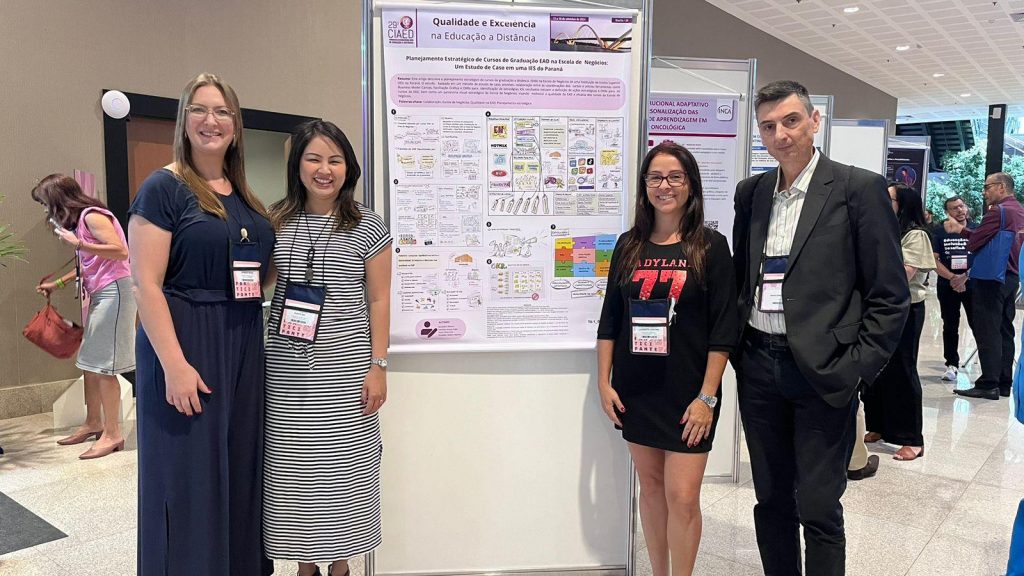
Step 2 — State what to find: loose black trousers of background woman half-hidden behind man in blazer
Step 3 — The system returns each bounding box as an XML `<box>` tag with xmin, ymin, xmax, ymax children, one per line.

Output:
<box><xmin>864</xmin><ymin>302</ymin><xmax>925</xmax><ymax>446</ymax></box>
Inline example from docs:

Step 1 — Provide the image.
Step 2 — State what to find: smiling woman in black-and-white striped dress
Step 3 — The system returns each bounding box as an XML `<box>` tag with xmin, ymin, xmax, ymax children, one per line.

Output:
<box><xmin>263</xmin><ymin>121</ymin><xmax>391</xmax><ymax>576</ymax></box>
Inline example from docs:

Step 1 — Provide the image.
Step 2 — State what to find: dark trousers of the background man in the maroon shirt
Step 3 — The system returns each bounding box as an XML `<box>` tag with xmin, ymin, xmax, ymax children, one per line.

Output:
<box><xmin>970</xmin><ymin>273</ymin><xmax>1020</xmax><ymax>389</ymax></box>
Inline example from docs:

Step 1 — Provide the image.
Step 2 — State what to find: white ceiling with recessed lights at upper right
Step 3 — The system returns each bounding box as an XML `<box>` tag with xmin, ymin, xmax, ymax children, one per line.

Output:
<box><xmin>708</xmin><ymin>0</ymin><xmax>1024</xmax><ymax>123</ymax></box>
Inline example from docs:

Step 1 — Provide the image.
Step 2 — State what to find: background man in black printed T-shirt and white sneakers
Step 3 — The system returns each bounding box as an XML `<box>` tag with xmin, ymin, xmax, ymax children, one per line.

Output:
<box><xmin>932</xmin><ymin>196</ymin><xmax>977</xmax><ymax>382</ymax></box>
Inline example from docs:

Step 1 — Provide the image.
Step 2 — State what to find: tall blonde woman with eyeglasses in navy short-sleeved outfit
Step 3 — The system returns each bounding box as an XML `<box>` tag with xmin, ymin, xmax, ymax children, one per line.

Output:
<box><xmin>128</xmin><ymin>74</ymin><xmax>274</xmax><ymax>576</ymax></box>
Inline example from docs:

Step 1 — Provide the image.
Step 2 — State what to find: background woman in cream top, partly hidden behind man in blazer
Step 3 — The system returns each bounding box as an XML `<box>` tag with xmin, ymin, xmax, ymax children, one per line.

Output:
<box><xmin>864</xmin><ymin>182</ymin><xmax>935</xmax><ymax>460</ymax></box>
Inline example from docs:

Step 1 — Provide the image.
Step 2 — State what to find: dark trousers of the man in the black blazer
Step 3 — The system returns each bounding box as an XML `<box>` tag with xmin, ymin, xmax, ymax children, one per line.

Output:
<box><xmin>737</xmin><ymin>329</ymin><xmax>858</xmax><ymax>576</ymax></box>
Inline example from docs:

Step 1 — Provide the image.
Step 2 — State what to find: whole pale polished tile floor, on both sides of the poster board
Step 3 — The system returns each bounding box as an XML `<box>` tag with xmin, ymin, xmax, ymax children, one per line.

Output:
<box><xmin>0</xmin><ymin>291</ymin><xmax>1024</xmax><ymax>576</ymax></box>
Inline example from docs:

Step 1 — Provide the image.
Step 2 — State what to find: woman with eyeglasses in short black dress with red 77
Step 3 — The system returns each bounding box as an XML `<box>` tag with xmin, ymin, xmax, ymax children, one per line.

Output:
<box><xmin>597</xmin><ymin>141</ymin><xmax>738</xmax><ymax>576</ymax></box>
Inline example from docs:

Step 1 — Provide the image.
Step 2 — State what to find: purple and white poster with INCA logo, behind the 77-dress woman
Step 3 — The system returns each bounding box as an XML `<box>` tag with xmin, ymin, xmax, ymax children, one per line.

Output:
<box><xmin>647</xmin><ymin>92</ymin><xmax>738</xmax><ymax>241</ymax></box>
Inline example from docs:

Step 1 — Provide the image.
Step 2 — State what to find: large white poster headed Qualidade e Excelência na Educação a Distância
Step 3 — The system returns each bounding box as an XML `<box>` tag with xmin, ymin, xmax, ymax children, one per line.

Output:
<box><xmin>382</xmin><ymin>4</ymin><xmax>635</xmax><ymax>352</ymax></box>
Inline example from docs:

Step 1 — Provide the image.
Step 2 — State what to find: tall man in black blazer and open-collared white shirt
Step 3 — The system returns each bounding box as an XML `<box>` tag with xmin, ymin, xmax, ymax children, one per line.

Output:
<box><xmin>732</xmin><ymin>81</ymin><xmax>909</xmax><ymax>576</ymax></box>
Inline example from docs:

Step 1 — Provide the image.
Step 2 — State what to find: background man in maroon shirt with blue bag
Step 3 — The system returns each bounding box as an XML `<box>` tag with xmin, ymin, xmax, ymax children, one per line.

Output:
<box><xmin>950</xmin><ymin>172</ymin><xmax>1024</xmax><ymax>400</ymax></box>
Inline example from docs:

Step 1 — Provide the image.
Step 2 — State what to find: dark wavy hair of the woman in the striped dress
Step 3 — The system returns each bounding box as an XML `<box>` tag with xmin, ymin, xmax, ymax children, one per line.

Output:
<box><xmin>270</xmin><ymin>120</ymin><xmax>362</xmax><ymax>232</ymax></box>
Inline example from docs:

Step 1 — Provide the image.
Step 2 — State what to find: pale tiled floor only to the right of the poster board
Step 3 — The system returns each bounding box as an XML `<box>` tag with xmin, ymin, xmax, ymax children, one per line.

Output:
<box><xmin>637</xmin><ymin>296</ymin><xmax>1024</xmax><ymax>576</ymax></box>
